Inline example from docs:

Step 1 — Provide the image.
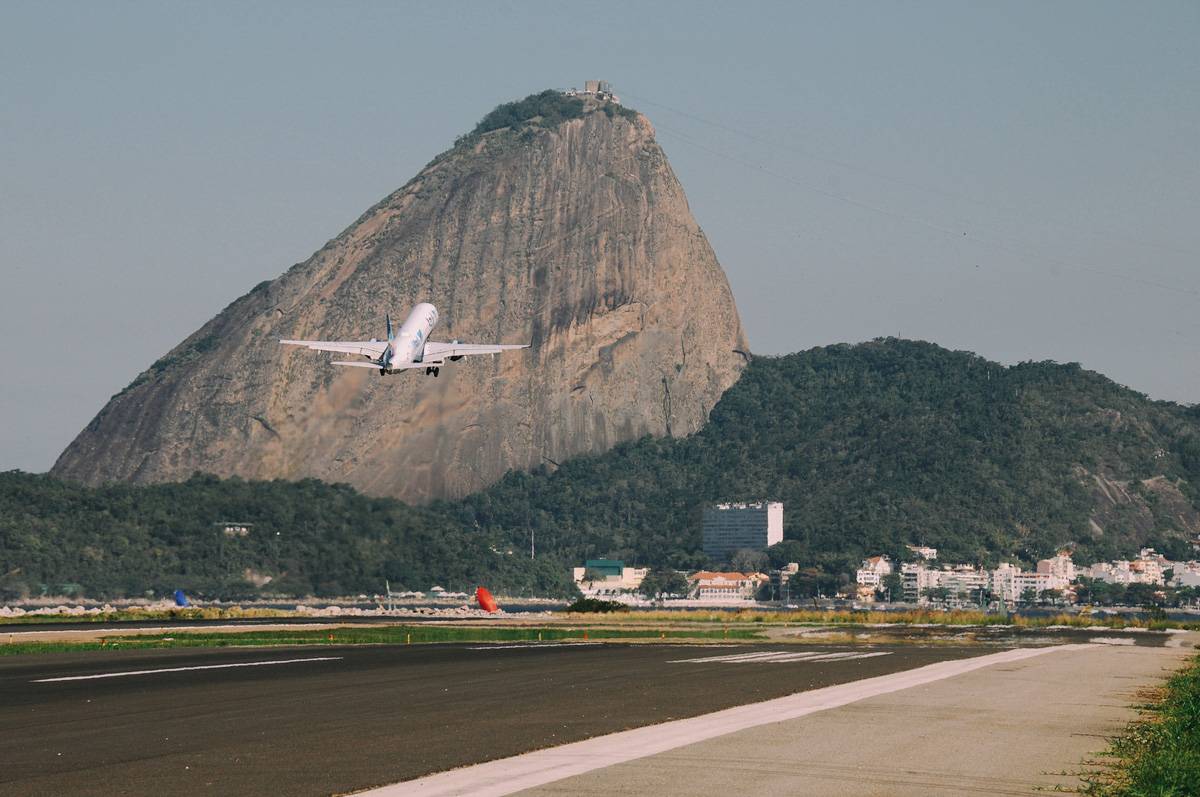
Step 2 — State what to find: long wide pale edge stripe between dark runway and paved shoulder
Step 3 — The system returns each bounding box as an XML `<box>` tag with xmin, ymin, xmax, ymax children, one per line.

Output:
<box><xmin>359</xmin><ymin>645</ymin><xmax>1091</xmax><ymax>797</ymax></box>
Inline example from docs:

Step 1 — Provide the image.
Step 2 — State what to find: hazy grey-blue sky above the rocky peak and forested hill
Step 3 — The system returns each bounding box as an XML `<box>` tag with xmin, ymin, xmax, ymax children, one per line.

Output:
<box><xmin>0</xmin><ymin>0</ymin><xmax>1200</xmax><ymax>472</ymax></box>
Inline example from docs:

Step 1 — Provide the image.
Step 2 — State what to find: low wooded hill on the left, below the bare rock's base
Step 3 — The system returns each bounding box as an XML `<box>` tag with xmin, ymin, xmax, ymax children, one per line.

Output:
<box><xmin>0</xmin><ymin>472</ymin><xmax>574</xmax><ymax>601</ymax></box>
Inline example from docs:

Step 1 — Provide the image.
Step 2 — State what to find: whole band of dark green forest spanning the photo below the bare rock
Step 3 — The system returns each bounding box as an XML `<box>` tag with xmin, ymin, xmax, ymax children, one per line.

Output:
<box><xmin>0</xmin><ymin>340</ymin><xmax>1200</xmax><ymax>594</ymax></box>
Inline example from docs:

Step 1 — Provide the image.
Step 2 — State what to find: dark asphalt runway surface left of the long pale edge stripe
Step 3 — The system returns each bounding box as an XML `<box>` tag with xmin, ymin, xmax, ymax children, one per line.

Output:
<box><xmin>0</xmin><ymin>643</ymin><xmax>995</xmax><ymax>795</ymax></box>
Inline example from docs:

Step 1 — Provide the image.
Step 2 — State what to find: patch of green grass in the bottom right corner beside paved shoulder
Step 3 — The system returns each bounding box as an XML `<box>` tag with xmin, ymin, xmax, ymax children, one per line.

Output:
<box><xmin>1082</xmin><ymin>658</ymin><xmax>1200</xmax><ymax>797</ymax></box>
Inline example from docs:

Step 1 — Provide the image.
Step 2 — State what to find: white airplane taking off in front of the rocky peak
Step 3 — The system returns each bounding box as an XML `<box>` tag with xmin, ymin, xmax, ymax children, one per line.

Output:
<box><xmin>280</xmin><ymin>301</ymin><xmax>529</xmax><ymax>377</ymax></box>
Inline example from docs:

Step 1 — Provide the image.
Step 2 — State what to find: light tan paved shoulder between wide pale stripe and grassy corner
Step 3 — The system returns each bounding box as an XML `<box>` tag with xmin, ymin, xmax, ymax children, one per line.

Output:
<box><xmin>522</xmin><ymin>645</ymin><xmax>1192</xmax><ymax>797</ymax></box>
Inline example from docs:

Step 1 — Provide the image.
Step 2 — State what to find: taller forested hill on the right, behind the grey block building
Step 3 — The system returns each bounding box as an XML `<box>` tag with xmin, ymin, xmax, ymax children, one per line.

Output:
<box><xmin>454</xmin><ymin>338</ymin><xmax>1200</xmax><ymax>574</ymax></box>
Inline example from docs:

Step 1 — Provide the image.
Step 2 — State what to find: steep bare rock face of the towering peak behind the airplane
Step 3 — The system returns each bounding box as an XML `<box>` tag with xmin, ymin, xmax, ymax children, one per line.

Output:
<box><xmin>53</xmin><ymin>100</ymin><xmax>746</xmax><ymax>501</ymax></box>
